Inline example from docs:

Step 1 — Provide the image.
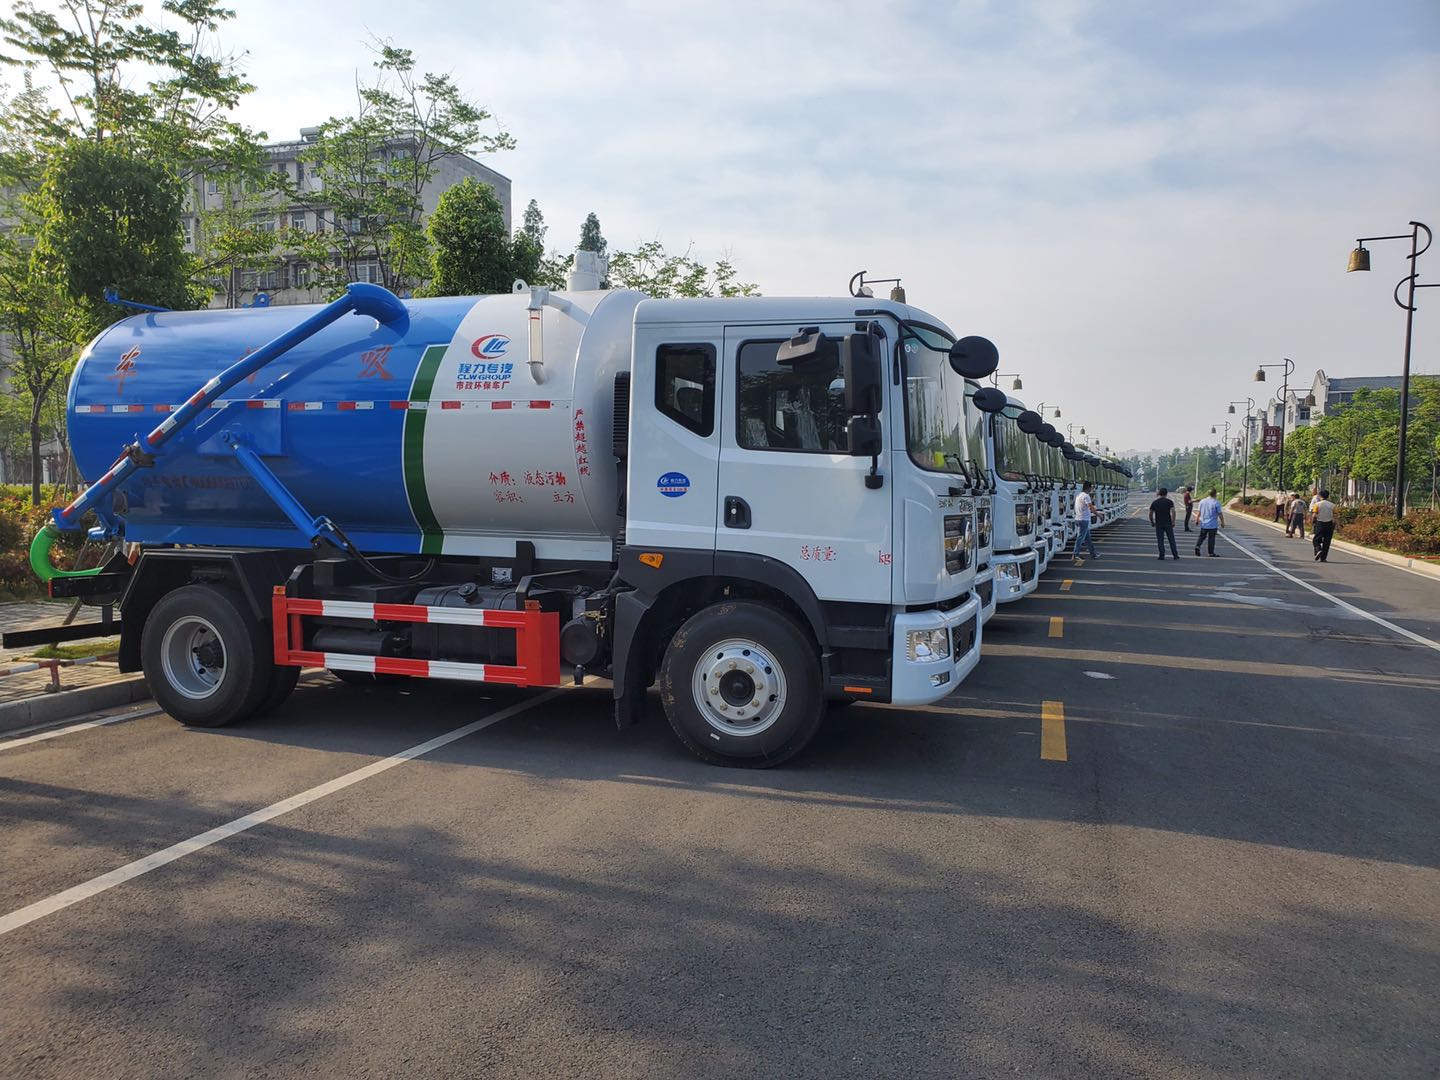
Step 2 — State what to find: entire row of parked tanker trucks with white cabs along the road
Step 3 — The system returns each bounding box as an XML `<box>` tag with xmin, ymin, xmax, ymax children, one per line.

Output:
<box><xmin>32</xmin><ymin>253</ymin><xmax>1128</xmax><ymax>765</ymax></box>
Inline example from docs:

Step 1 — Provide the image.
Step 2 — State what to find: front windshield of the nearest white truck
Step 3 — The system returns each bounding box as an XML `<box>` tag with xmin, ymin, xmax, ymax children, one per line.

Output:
<box><xmin>900</xmin><ymin>323</ymin><xmax>985</xmax><ymax>478</ymax></box>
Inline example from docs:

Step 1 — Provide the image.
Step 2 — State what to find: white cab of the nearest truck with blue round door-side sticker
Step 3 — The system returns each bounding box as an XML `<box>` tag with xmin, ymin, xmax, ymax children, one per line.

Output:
<box><xmin>615</xmin><ymin>298</ymin><xmax>998</xmax><ymax>759</ymax></box>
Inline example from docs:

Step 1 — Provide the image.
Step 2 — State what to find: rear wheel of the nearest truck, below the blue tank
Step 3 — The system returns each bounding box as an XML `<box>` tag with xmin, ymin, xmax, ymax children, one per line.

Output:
<box><xmin>140</xmin><ymin>585</ymin><xmax>275</xmax><ymax>727</ymax></box>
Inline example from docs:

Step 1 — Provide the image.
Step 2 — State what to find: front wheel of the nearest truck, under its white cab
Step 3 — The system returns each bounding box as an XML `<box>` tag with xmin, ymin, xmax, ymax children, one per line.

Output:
<box><xmin>660</xmin><ymin>600</ymin><xmax>825</xmax><ymax>769</ymax></box>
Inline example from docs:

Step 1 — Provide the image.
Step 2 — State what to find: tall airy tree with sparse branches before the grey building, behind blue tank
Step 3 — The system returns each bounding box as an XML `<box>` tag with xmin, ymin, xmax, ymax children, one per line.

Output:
<box><xmin>288</xmin><ymin>42</ymin><xmax>516</xmax><ymax>298</ymax></box>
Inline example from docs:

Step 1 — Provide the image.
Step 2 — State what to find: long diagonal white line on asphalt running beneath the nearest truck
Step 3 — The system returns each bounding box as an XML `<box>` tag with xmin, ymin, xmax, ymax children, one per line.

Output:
<box><xmin>0</xmin><ymin>690</ymin><xmax>564</xmax><ymax>936</ymax></box>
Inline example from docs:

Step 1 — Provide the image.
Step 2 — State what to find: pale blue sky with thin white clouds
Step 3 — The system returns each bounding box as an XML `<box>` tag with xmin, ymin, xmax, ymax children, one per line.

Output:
<box><xmin>132</xmin><ymin>0</ymin><xmax>1440</xmax><ymax>452</ymax></box>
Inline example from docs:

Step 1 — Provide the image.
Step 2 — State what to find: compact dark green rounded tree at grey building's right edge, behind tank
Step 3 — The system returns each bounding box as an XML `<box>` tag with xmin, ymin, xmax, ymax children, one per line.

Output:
<box><xmin>425</xmin><ymin>177</ymin><xmax>539</xmax><ymax>297</ymax></box>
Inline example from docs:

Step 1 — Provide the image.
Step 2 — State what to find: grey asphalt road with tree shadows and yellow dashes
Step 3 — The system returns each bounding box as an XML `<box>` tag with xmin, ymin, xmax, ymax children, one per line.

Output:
<box><xmin>0</xmin><ymin>506</ymin><xmax>1440</xmax><ymax>1077</ymax></box>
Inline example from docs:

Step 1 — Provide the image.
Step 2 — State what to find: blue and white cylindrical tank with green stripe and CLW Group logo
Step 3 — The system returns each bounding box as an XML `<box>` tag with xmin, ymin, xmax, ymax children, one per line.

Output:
<box><xmin>68</xmin><ymin>291</ymin><xmax>644</xmax><ymax>559</ymax></box>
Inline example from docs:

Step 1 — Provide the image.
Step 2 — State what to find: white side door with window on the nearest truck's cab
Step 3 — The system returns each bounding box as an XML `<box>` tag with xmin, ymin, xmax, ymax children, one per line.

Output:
<box><xmin>716</xmin><ymin>321</ymin><xmax>894</xmax><ymax>603</ymax></box>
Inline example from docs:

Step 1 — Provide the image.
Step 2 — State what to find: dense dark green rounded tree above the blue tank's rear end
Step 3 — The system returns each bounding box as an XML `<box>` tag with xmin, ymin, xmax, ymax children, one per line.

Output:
<box><xmin>33</xmin><ymin>140</ymin><xmax>204</xmax><ymax>329</ymax></box>
